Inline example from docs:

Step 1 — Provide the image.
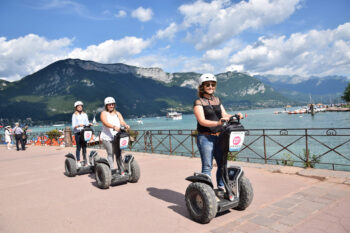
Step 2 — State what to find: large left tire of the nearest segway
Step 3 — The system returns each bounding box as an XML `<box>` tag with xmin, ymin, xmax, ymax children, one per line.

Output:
<box><xmin>185</xmin><ymin>182</ymin><xmax>218</xmax><ymax>224</ymax></box>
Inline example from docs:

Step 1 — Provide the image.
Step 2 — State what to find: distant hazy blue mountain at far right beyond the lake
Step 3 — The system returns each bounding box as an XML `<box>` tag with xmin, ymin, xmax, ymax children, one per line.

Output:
<box><xmin>254</xmin><ymin>75</ymin><xmax>350</xmax><ymax>103</ymax></box>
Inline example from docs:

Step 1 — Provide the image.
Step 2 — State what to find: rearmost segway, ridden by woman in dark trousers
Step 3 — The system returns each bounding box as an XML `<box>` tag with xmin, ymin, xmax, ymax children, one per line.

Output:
<box><xmin>64</xmin><ymin>126</ymin><xmax>99</xmax><ymax>177</ymax></box>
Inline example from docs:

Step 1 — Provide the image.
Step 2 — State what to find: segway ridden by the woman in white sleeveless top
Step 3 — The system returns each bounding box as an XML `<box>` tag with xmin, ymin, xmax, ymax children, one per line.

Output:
<box><xmin>95</xmin><ymin>126</ymin><xmax>140</xmax><ymax>189</ymax></box>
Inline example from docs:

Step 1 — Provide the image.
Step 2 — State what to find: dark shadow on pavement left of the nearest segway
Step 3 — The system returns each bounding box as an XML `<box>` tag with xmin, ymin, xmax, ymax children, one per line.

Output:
<box><xmin>147</xmin><ymin>187</ymin><xmax>190</xmax><ymax>219</ymax></box>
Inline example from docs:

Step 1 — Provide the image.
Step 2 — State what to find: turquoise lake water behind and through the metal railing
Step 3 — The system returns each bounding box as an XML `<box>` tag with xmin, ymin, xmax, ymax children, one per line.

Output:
<box><xmin>3</xmin><ymin>108</ymin><xmax>350</xmax><ymax>170</ymax></box>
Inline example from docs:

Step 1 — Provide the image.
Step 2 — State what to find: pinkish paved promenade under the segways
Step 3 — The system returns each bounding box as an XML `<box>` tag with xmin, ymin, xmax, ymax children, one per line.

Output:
<box><xmin>0</xmin><ymin>145</ymin><xmax>350</xmax><ymax>233</ymax></box>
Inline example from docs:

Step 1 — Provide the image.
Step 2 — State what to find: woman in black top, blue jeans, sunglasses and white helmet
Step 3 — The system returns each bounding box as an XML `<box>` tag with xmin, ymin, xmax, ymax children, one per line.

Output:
<box><xmin>193</xmin><ymin>74</ymin><xmax>242</xmax><ymax>190</ymax></box>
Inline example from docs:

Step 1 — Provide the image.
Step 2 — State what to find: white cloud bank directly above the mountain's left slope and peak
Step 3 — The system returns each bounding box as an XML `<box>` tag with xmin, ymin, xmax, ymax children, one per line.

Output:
<box><xmin>0</xmin><ymin>34</ymin><xmax>151</xmax><ymax>81</ymax></box>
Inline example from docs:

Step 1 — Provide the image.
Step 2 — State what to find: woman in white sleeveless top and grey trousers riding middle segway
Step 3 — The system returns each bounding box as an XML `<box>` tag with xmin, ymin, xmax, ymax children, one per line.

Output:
<box><xmin>101</xmin><ymin>97</ymin><xmax>130</xmax><ymax>171</ymax></box>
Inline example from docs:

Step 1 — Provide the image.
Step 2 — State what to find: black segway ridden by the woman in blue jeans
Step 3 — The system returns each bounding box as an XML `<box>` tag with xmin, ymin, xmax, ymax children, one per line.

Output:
<box><xmin>185</xmin><ymin>115</ymin><xmax>254</xmax><ymax>224</ymax></box>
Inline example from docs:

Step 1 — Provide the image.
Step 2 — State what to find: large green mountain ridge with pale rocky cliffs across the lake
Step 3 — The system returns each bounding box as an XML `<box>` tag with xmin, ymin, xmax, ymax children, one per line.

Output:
<box><xmin>0</xmin><ymin>59</ymin><xmax>290</xmax><ymax>122</ymax></box>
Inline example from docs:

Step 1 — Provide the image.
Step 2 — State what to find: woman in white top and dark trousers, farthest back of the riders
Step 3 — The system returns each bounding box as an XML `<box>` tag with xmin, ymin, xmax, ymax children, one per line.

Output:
<box><xmin>72</xmin><ymin>101</ymin><xmax>91</xmax><ymax>167</ymax></box>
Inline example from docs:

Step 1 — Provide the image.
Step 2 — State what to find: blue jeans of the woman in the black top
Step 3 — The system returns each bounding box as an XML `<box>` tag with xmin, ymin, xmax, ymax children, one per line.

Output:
<box><xmin>197</xmin><ymin>134</ymin><xmax>224</xmax><ymax>186</ymax></box>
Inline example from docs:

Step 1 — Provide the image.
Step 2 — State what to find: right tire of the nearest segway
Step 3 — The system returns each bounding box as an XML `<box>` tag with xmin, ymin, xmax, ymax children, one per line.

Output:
<box><xmin>234</xmin><ymin>176</ymin><xmax>254</xmax><ymax>210</ymax></box>
